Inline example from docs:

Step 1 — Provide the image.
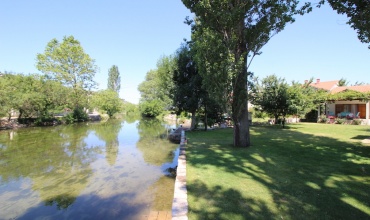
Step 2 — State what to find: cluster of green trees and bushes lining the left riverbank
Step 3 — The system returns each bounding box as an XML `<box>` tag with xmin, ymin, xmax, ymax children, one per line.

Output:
<box><xmin>0</xmin><ymin>36</ymin><xmax>127</xmax><ymax>123</ymax></box>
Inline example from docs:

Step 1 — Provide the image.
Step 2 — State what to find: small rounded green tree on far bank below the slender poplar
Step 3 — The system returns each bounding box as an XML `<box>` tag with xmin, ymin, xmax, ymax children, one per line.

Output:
<box><xmin>91</xmin><ymin>89</ymin><xmax>123</xmax><ymax>117</ymax></box>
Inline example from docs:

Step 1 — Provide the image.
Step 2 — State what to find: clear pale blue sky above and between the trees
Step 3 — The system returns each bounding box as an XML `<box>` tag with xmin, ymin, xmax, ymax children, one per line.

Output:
<box><xmin>0</xmin><ymin>0</ymin><xmax>370</xmax><ymax>103</ymax></box>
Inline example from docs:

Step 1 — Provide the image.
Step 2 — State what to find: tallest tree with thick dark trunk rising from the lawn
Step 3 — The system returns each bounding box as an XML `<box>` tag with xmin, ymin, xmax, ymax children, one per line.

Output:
<box><xmin>182</xmin><ymin>0</ymin><xmax>306</xmax><ymax>147</ymax></box>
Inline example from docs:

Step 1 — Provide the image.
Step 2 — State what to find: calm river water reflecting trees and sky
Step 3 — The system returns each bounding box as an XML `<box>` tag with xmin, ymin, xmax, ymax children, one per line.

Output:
<box><xmin>0</xmin><ymin>120</ymin><xmax>178</xmax><ymax>219</ymax></box>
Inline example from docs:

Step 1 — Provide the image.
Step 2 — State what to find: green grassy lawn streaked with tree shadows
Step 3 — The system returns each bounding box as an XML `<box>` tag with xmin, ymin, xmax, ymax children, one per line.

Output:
<box><xmin>186</xmin><ymin>123</ymin><xmax>370</xmax><ymax>220</ymax></box>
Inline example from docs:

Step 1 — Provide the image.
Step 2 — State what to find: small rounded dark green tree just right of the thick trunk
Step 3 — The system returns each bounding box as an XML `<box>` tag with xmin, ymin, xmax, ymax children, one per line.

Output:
<box><xmin>253</xmin><ymin>75</ymin><xmax>291</xmax><ymax>124</ymax></box>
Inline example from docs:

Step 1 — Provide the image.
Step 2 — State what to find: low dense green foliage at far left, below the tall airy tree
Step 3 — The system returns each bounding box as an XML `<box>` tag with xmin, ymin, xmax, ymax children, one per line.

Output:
<box><xmin>0</xmin><ymin>74</ymin><xmax>70</xmax><ymax>118</ymax></box>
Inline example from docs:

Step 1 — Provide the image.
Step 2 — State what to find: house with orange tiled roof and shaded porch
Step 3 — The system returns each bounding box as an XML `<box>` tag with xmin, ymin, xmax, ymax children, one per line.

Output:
<box><xmin>310</xmin><ymin>79</ymin><xmax>370</xmax><ymax>125</ymax></box>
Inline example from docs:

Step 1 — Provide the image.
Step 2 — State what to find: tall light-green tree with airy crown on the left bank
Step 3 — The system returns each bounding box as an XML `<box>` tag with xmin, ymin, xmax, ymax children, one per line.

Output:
<box><xmin>36</xmin><ymin>36</ymin><xmax>97</xmax><ymax>108</ymax></box>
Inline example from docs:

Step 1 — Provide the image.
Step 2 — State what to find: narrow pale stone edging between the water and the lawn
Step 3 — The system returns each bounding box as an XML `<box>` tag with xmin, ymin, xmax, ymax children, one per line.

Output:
<box><xmin>172</xmin><ymin>130</ymin><xmax>188</xmax><ymax>220</ymax></box>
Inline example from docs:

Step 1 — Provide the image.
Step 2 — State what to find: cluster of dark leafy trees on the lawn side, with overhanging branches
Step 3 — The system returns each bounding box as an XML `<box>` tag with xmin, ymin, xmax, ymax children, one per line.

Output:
<box><xmin>139</xmin><ymin>0</ymin><xmax>369</xmax><ymax>147</ymax></box>
